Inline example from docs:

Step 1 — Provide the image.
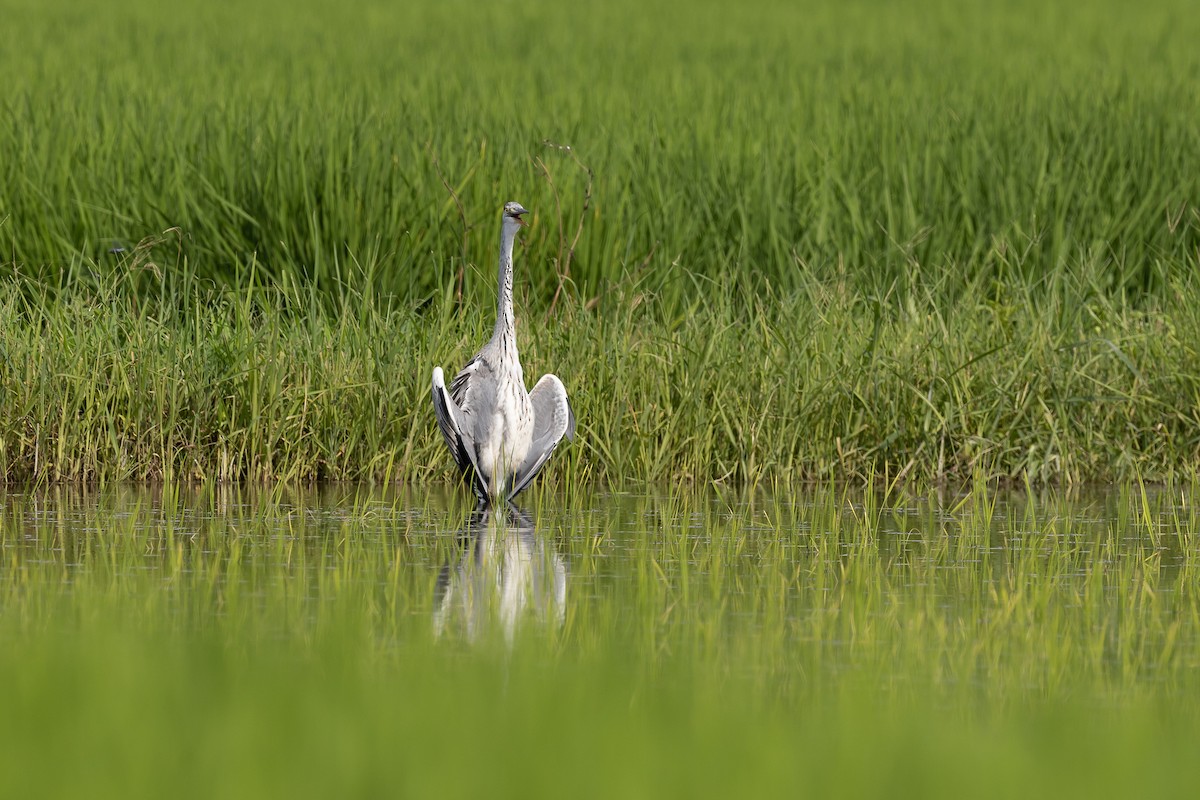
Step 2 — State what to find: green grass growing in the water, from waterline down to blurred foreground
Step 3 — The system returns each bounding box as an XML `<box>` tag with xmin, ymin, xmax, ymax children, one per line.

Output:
<box><xmin>0</xmin><ymin>483</ymin><xmax>1200</xmax><ymax>798</ymax></box>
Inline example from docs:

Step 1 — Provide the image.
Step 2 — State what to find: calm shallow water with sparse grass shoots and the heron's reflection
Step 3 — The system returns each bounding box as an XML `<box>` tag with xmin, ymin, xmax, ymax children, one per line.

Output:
<box><xmin>0</xmin><ymin>486</ymin><xmax>1200</xmax><ymax>675</ymax></box>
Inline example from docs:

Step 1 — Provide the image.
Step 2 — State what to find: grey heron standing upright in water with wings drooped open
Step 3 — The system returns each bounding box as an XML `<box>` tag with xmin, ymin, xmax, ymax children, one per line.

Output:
<box><xmin>433</xmin><ymin>203</ymin><xmax>575</xmax><ymax>504</ymax></box>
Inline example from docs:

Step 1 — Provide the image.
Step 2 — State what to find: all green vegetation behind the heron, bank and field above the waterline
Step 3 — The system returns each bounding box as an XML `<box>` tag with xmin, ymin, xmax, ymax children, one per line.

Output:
<box><xmin>0</xmin><ymin>0</ymin><xmax>1200</xmax><ymax>486</ymax></box>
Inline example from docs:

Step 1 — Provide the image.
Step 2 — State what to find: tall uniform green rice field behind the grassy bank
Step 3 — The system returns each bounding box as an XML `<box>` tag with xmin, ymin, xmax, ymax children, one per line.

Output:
<box><xmin>0</xmin><ymin>0</ymin><xmax>1200</xmax><ymax>311</ymax></box>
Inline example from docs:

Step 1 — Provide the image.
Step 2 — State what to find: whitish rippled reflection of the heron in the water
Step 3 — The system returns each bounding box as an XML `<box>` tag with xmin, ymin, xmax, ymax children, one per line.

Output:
<box><xmin>433</xmin><ymin>504</ymin><xmax>566</xmax><ymax>644</ymax></box>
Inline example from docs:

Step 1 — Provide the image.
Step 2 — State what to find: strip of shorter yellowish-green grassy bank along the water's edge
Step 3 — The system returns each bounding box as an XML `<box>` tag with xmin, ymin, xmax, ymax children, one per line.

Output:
<box><xmin>0</xmin><ymin>266</ymin><xmax>1200</xmax><ymax>487</ymax></box>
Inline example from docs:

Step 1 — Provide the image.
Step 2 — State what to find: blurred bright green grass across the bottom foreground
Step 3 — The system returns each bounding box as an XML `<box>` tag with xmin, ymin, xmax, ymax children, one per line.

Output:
<box><xmin>7</xmin><ymin>631</ymin><xmax>1200</xmax><ymax>798</ymax></box>
